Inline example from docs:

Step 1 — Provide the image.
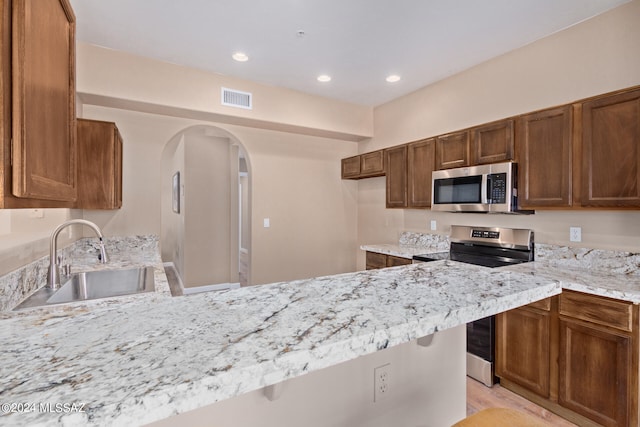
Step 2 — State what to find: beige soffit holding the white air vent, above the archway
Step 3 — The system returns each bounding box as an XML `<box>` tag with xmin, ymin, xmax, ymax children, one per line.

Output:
<box><xmin>76</xmin><ymin>43</ymin><xmax>373</xmax><ymax>141</ymax></box>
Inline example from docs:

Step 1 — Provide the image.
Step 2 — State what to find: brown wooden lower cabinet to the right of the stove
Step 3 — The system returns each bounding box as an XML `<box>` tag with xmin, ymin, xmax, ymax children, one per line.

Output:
<box><xmin>496</xmin><ymin>291</ymin><xmax>640</xmax><ymax>426</ymax></box>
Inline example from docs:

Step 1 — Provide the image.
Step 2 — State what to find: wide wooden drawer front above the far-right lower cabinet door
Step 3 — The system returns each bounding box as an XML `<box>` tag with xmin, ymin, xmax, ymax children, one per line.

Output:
<box><xmin>560</xmin><ymin>291</ymin><xmax>633</xmax><ymax>332</ymax></box>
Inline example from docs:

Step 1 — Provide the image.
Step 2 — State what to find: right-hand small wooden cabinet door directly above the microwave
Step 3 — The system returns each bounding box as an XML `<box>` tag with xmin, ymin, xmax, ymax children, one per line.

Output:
<box><xmin>472</xmin><ymin>119</ymin><xmax>514</xmax><ymax>165</ymax></box>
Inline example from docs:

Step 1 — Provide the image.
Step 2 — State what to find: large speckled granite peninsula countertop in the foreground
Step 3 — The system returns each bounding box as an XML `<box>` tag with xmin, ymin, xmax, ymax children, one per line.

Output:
<box><xmin>0</xmin><ymin>261</ymin><xmax>561</xmax><ymax>426</ymax></box>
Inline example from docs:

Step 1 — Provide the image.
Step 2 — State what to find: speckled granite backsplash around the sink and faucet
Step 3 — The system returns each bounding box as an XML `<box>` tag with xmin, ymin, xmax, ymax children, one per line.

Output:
<box><xmin>0</xmin><ymin>235</ymin><xmax>162</xmax><ymax>311</ymax></box>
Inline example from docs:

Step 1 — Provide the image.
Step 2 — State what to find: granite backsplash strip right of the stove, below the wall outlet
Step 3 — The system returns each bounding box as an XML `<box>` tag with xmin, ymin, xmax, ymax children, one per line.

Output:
<box><xmin>535</xmin><ymin>243</ymin><xmax>640</xmax><ymax>275</ymax></box>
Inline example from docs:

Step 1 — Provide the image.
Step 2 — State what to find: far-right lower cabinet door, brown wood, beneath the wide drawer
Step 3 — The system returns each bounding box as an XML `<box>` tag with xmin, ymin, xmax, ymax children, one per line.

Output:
<box><xmin>558</xmin><ymin>318</ymin><xmax>638</xmax><ymax>426</ymax></box>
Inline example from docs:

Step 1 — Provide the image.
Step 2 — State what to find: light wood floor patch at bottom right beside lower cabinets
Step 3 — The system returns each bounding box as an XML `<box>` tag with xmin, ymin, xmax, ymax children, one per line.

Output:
<box><xmin>467</xmin><ymin>377</ymin><xmax>576</xmax><ymax>427</ymax></box>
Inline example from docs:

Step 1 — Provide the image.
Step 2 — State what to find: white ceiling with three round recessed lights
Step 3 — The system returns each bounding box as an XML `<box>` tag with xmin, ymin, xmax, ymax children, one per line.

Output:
<box><xmin>71</xmin><ymin>0</ymin><xmax>629</xmax><ymax>106</ymax></box>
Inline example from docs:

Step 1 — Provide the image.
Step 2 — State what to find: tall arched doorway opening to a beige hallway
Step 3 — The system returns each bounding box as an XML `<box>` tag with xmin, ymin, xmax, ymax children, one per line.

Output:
<box><xmin>160</xmin><ymin>125</ymin><xmax>251</xmax><ymax>293</ymax></box>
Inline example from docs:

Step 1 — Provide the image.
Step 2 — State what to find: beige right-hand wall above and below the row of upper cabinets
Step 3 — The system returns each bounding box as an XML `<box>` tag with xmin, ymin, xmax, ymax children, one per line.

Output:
<box><xmin>358</xmin><ymin>0</ymin><xmax>640</xmax><ymax>267</ymax></box>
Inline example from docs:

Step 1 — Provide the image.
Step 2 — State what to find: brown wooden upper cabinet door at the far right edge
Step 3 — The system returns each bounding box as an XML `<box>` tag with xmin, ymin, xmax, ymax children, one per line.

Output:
<box><xmin>581</xmin><ymin>90</ymin><xmax>640</xmax><ymax>207</ymax></box>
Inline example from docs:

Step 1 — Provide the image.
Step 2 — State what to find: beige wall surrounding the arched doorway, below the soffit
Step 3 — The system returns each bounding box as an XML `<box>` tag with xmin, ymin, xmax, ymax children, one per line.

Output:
<box><xmin>77</xmin><ymin>105</ymin><xmax>357</xmax><ymax>284</ymax></box>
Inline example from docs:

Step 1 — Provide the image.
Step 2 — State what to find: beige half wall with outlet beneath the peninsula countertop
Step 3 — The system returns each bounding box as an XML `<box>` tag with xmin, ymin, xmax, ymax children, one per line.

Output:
<box><xmin>149</xmin><ymin>325</ymin><xmax>466</xmax><ymax>427</ymax></box>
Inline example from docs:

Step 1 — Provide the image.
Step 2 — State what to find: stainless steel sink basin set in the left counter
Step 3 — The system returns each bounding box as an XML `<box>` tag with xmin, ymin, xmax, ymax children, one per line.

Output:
<box><xmin>14</xmin><ymin>267</ymin><xmax>155</xmax><ymax>310</ymax></box>
